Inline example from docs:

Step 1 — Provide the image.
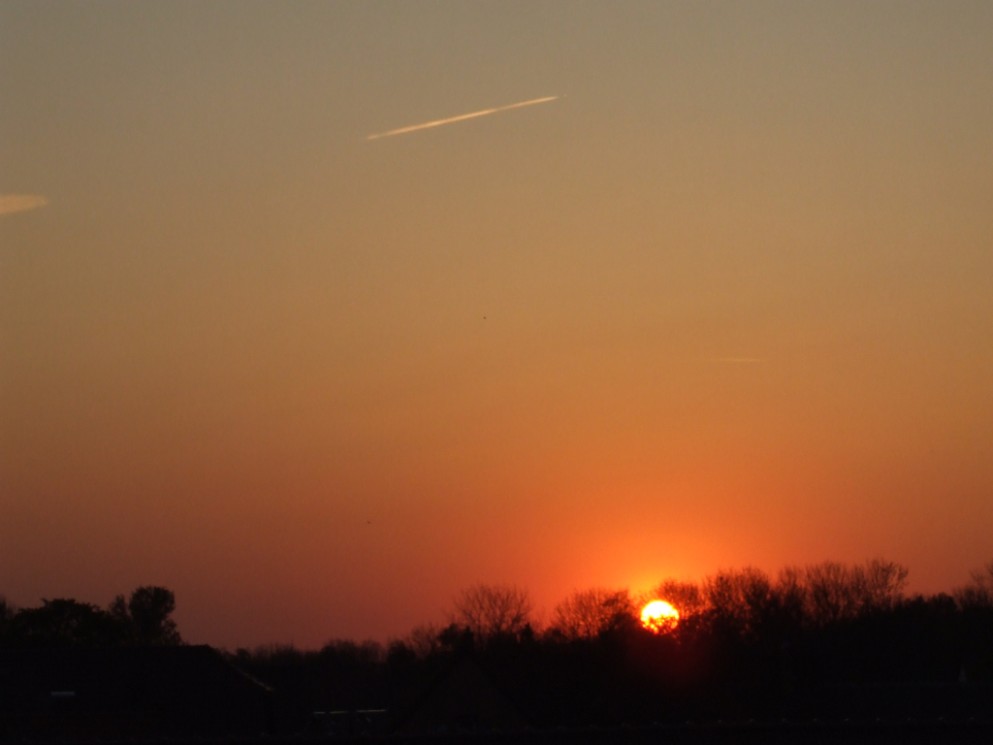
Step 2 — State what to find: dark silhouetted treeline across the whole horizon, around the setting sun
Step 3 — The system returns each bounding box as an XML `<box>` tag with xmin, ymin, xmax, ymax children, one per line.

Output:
<box><xmin>0</xmin><ymin>560</ymin><xmax>993</xmax><ymax>733</ymax></box>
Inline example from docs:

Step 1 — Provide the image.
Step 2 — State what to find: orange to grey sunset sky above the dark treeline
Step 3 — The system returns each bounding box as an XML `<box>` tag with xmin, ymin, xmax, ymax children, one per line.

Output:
<box><xmin>0</xmin><ymin>0</ymin><xmax>993</xmax><ymax>649</ymax></box>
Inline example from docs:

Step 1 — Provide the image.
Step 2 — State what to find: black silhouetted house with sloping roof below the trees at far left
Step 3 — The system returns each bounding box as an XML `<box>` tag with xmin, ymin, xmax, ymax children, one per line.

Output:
<box><xmin>0</xmin><ymin>646</ymin><xmax>272</xmax><ymax>741</ymax></box>
